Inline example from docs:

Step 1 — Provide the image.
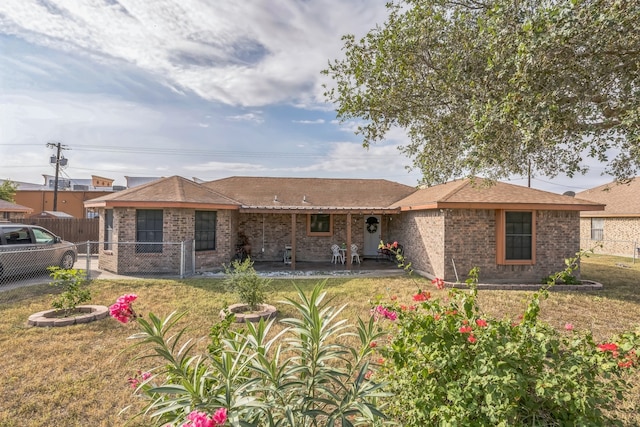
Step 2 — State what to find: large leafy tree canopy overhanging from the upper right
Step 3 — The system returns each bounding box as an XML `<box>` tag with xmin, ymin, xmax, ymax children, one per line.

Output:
<box><xmin>324</xmin><ymin>0</ymin><xmax>640</xmax><ymax>184</ymax></box>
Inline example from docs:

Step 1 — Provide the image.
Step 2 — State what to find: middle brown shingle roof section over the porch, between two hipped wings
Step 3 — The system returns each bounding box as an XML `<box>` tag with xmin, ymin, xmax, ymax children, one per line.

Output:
<box><xmin>202</xmin><ymin>176</ymin><xmax>416</xmax><ymax>211</ymax></box>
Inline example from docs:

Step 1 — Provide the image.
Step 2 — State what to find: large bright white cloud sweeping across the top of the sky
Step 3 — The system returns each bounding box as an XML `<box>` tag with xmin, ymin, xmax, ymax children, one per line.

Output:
<box><xmin>0</xmin><ymin>0</ymin><xmax>386</xmax><ymax>106</ymax></box>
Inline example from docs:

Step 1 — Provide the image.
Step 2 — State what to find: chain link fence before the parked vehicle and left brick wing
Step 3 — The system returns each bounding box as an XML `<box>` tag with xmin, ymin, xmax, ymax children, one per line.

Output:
<box><xmin>0</xmin><ymin>240</ymin><xmax>195</xmax><ymax>298</ymax></box>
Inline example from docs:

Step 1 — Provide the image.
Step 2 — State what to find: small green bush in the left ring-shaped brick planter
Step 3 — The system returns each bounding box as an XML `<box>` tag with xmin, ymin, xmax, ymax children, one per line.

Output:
<box><xmin>48</xmin><ymin>266</ymin><xmax>91</xmax><ymax>316</ymax></box>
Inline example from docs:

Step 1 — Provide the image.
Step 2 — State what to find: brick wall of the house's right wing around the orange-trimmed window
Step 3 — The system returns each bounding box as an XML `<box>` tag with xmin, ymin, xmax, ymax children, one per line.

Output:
<box><xmin>391</xmin><ymin>209</ymin><xmax>580</xmax><ymax>283</ymax></box>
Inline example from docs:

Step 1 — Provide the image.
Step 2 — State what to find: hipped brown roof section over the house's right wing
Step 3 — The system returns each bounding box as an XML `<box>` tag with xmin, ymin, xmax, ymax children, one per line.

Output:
<box><xmin>395</xmin><ymin>178</ymin><xmax>604</xmax><ymax>211</ymax></box>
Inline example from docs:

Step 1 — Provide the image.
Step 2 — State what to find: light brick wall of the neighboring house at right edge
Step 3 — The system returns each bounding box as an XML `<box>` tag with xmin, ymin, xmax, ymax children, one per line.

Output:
<box><xmin>580</xmin><ymin>217</ymin><xmax>640</xmax><ymax>258</ymax></box>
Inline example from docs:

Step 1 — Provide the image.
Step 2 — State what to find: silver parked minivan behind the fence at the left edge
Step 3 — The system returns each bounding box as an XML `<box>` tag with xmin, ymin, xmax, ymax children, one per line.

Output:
<box><xmin>0</xmin><ymin>223</ymin><xmax>78</xmax><ymax>278</ymax></box>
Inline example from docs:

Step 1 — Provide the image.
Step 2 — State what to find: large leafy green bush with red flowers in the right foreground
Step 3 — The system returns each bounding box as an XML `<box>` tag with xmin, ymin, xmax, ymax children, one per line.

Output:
<box><xmin>378</xmin><ymin>244</ymin><xmax>640</xmax><ymax>426</ymax></box>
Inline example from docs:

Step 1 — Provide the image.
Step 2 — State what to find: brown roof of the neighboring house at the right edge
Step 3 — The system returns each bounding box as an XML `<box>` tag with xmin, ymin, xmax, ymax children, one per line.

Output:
<box><xmin>576</xmin><ymin>177</ymin><xmax>640</xmax><ymax>217</ymax></box>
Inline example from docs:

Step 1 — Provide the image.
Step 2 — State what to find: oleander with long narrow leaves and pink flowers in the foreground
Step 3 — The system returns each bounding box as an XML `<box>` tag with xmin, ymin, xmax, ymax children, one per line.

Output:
<box><xmin>109</xmin><ymin>284</ymin><xmax>384</xmax><ymax>427</ymax></box>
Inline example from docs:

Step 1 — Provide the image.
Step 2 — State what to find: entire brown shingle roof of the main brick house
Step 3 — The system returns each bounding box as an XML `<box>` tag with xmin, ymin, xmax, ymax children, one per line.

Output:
<box><xmin>85</xmin><ymin>176</ymin><xmax>604</xmax><ymax>212</ymax></box>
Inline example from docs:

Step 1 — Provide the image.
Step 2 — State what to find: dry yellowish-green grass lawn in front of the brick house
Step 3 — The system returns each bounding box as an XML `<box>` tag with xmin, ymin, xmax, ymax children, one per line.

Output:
<box><xmin>0</xmin><ymin>256</ymin><xmax>640</xmax><ymax>427</ymax></box>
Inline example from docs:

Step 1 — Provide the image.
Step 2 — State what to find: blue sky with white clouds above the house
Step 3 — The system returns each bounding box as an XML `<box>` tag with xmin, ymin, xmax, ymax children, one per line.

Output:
<box><xmin>0</xmin><ymin>0</ymin><xmax>611</xmax><ymax>193</ymax></box>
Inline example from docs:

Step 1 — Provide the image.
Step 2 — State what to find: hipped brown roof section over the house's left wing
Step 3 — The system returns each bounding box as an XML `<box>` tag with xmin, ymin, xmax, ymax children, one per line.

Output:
<box><xmin>84</xmin><ymin>176</ymin><xmax>240</xmax><ymax>209</ymax></box>
